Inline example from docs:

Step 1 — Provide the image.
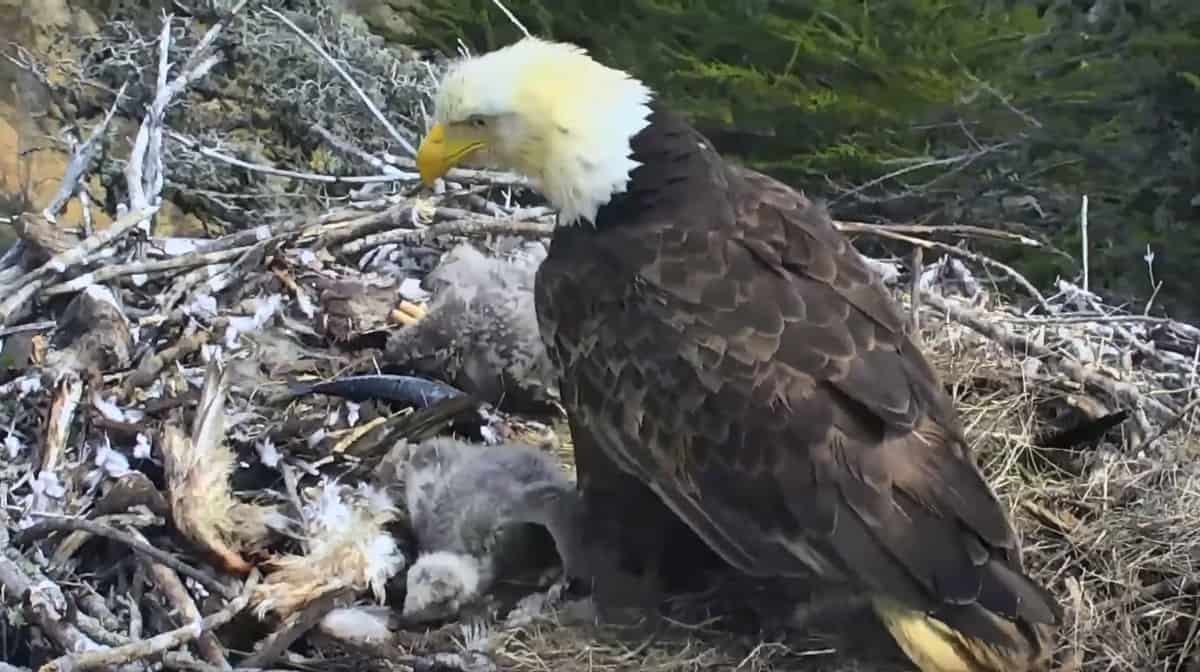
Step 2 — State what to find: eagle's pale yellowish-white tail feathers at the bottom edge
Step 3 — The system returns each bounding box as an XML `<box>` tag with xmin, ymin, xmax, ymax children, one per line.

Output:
<box><xmin>871</xmin><ymin>595</ymin><xmax>1051</xmax><ymax>672</ymax></box>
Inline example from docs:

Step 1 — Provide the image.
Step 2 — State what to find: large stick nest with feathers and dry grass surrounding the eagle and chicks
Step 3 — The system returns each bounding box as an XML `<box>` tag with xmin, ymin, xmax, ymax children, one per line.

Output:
<box><xmin>0</xmin><ymin>2</ymin><xmax>1200</xmax><ymax>672</ymax></box>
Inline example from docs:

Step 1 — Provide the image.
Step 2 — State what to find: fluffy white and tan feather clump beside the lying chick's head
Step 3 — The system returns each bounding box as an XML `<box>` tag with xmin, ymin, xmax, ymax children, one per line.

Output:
<box><xmin>253</xmin><ymin>480</ymin><xmax>407</xmax><ymax>619</ymax></box>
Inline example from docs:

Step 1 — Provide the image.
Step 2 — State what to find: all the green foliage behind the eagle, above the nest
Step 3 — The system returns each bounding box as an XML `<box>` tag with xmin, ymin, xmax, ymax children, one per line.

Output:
<box><xmin>416</xmin><ymin>0</ymin><xmax>1200</xmax><ymax>314</ymax></box>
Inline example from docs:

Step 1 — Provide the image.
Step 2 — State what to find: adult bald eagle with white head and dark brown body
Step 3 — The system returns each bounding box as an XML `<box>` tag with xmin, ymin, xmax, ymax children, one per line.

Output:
<box><xmin>416</xmin><ymin>38</ymin><xmax>1061</xmax><ymax>672</ymax></box>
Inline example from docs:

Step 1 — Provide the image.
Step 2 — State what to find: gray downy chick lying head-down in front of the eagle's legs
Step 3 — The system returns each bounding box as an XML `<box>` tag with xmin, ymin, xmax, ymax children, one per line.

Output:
<box><xmin>403</xmin><ymin>438</ymin><xmax>580</xmax><ymax>622</ymax></box>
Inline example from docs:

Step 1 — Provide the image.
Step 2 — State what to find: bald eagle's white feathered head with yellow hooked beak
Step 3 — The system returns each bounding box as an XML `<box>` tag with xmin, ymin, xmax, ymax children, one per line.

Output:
<box><xmin>416</xmin><ymin>37</ymin><xmax>652</xmax><ymax>223</ymax></box>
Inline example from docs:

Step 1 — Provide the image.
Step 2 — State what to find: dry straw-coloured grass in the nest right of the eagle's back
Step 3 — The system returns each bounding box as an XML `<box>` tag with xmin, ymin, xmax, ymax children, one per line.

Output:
<box><xmin>924</xmin><ymin>302</ymin><xmax>1200</xmax><ymax>670</ymax></box>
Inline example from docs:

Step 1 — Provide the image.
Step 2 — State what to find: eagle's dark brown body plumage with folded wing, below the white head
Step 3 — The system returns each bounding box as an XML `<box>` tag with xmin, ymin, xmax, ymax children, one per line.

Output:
<box><xmin>536</xmin><ymin>115</ymin><xmax>1058</xmax><ymax>652</ymax></box>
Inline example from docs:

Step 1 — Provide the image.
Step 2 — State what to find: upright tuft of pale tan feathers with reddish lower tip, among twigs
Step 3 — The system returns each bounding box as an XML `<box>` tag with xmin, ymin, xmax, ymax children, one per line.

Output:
<box><xmin>162</xmin><ymin>360</ymin><xmax>282</xmax><ymax>575</ymax></box>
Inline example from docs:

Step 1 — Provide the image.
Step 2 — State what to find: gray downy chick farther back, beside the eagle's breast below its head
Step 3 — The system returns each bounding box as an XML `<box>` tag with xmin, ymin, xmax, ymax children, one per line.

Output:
<box><xmin>385</xmin><ymin>241</ymin><xmax>558</xmax><ymax>410</ymax></box>
